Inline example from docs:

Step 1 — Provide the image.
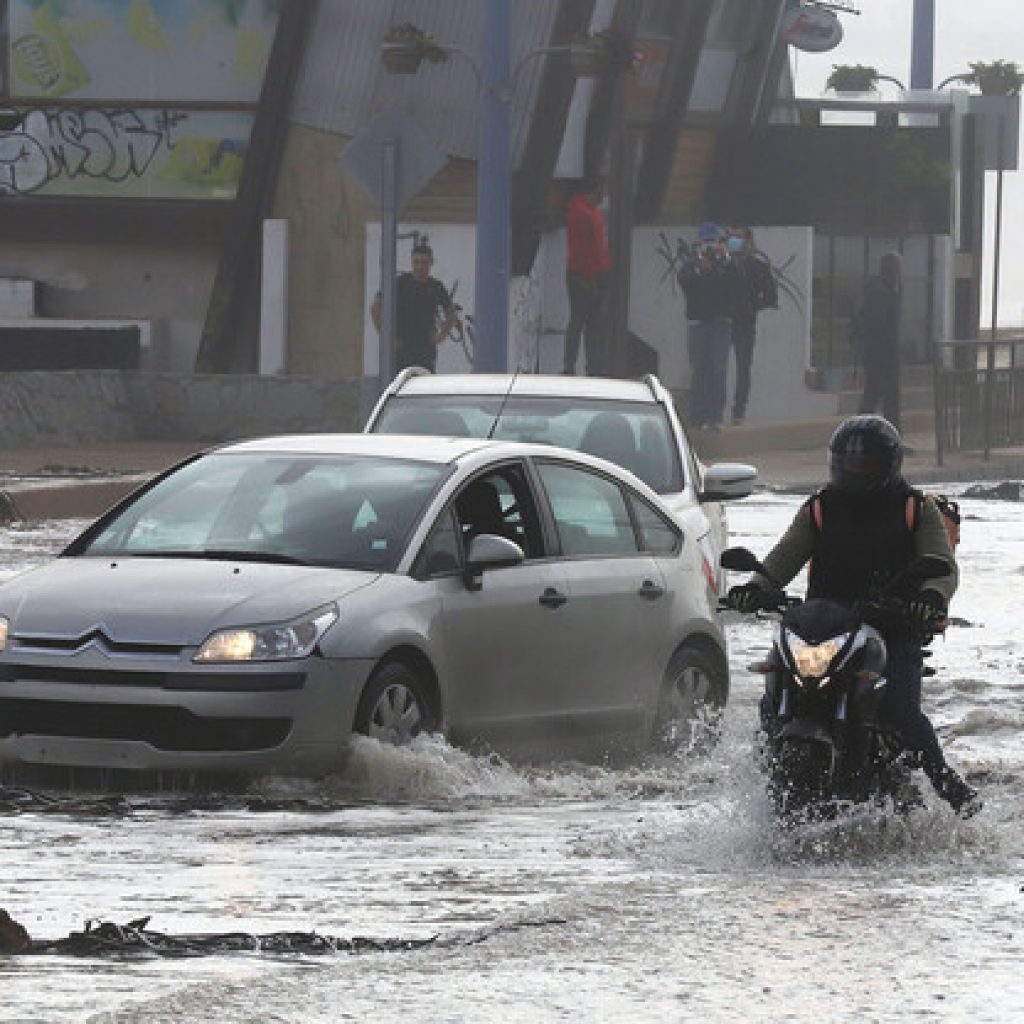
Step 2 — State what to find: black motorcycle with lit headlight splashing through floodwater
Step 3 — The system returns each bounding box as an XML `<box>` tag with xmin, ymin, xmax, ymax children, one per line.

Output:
<box><xmin>721</xmin><ymin>548</ymin><xmax>949</xmax><ymax>821</ymax></box>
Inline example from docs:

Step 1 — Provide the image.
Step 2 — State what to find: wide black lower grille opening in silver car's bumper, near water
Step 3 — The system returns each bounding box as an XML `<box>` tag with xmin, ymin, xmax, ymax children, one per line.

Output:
<box><xmin>0</xmin><ymin>698</ymin><xmax>292</xmax><ymax>752</ymax></box>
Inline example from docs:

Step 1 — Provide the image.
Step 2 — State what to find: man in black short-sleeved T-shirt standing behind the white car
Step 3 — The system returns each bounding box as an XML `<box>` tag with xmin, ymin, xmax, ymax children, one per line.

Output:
<box><xmin>370</xmin><ymin>241</ymin><xmax>459</xmax><ymax>373</ymax></box>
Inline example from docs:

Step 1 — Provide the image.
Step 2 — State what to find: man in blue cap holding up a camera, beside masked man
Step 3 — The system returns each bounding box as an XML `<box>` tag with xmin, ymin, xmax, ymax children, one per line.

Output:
<box><xmin>678</xmin><ymin>222</ymin><xmax>736</xmax><ymax>430</ymax></box>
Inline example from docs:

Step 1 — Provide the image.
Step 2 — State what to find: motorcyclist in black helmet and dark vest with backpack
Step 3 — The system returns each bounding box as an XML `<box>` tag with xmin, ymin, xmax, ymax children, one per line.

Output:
<box><xmin>728</xmin><ymin>415</ymin><xmax>981</xmax><ymax>817</ymax></box>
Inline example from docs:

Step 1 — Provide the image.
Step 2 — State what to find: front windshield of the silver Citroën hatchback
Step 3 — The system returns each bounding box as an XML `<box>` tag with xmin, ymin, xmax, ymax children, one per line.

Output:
<box><xmin>77</xmin><ymin>453</ymin><xmax>445</xmax><ymax>571</ymax></box>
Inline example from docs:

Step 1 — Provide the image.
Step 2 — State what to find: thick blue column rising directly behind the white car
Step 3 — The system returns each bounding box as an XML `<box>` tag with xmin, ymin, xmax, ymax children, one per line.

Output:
<box><xmin>473</xmin><ymin>0</ymin><xmax>512</xmax><ymax>374</ymax></box>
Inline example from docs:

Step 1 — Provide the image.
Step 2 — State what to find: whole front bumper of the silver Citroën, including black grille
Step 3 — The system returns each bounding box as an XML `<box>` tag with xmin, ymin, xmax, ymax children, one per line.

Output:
<box><xmin>0</xmin><ymin>650</ymin><xmax>373</xmax><ymax>775</ymax></box>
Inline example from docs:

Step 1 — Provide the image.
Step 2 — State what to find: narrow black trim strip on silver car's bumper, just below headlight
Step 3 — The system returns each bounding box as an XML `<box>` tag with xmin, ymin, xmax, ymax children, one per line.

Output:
<box><xmin>0</xmin><ymin>663</ymin><xmax>306</xmax><ymax>693</ymax></box>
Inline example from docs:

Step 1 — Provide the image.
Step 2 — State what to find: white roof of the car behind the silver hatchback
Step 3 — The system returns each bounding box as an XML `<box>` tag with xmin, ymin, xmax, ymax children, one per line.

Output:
<box><xmin>387</xmin><ymin>373</ymin><xmax>658</xmax><ymax>402</ymax></box>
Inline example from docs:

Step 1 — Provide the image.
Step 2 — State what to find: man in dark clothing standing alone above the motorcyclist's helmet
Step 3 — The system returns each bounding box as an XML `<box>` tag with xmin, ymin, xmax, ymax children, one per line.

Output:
<box><xmin>853</xmin><ymin>253</ymin><xmax>902</xmax><ymax>429</ymax></box>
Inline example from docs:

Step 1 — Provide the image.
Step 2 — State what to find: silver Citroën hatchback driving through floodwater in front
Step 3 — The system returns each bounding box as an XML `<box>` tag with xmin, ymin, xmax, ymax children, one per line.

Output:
<box><xmin>0</xmin><ymin>434</ymin><xmax>728</xmax><ymax>775</ymax></box>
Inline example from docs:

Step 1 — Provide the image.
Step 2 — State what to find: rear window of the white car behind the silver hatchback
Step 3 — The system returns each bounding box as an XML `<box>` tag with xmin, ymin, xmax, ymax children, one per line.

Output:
<box><xmin>372</xmin><ymin>394</ymin><xmax>684</xmax><ymax>495</ymax></box>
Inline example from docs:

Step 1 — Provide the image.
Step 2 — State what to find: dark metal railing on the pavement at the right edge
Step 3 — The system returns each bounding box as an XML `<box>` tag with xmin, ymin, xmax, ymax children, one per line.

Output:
<box><xmin>935</xmin><ymin>335</ymin><xmax>1024</xmax><ymax>466</ymax></box>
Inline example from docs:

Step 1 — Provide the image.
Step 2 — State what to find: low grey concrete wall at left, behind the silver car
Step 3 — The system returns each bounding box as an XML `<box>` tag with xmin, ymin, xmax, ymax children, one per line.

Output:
<box><xmin>0</xmin><ymin>370</ymin><xmax>372</xmax><ymax>447</ymax></box>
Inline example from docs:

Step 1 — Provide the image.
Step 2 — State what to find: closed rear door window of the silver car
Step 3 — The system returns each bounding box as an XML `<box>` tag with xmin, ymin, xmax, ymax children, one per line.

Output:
<box><xmin>538</xmin><ymin>462</ymin><xmax>639</xmax><ymax>557</ymax></box>
